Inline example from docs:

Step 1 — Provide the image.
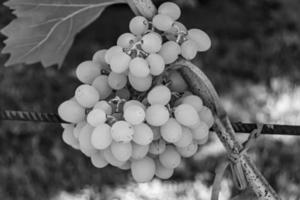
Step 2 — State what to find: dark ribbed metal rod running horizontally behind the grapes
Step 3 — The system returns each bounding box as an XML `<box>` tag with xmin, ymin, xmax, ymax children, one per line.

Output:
<box><xmin>0</xmin><ymin>110</ymin><xmax>300</xmax><ymax>136</ymax></box>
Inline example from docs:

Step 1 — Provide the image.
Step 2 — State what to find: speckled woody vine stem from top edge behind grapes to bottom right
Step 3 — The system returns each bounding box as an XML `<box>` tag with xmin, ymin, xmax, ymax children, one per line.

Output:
<box><xmin>127</xmin><ymin>0</ymin><xmax>280</xmax><ymax>200</ymax></box>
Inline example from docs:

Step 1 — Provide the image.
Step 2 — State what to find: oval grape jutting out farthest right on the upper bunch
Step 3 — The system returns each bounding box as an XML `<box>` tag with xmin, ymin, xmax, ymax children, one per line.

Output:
<box><xmin>188</xmin><ymin>29</ymin><xmax>211</xmax><ymax>51</ymax></box>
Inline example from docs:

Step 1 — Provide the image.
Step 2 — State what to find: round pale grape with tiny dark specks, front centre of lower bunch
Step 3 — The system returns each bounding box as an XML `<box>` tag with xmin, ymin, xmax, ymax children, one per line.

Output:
<box><xmin>111</xmin><ymin>121</ymin><xmax>134</xmax><ymax>142</ymax></box>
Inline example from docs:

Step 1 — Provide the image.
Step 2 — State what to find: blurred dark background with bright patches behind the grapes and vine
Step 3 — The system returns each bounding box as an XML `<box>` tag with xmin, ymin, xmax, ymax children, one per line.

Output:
<box><xmin>0</xmin><ymin>0</ymin><xmax>300</xmax><ymax>200</ymax></box>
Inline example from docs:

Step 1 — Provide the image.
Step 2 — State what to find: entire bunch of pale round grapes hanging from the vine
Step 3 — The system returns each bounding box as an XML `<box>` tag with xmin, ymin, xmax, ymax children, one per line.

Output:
<box><xmin>58</xmin><ymin>2</ymin><xmax>214</xmax><ymax>182</ymax></box>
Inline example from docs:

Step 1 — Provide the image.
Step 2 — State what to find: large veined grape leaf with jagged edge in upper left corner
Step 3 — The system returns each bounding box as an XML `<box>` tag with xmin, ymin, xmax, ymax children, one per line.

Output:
<box><xmin>1</xmin><ymin>0</ymin><xmax>125</xmax><ymax>67</ymax></box>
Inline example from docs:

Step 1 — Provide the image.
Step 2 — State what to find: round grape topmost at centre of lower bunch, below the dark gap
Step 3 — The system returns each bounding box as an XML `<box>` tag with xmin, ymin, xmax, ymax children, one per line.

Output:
<box><xmin>147</xmin><ymin>85</ymin><xmax>171</xmax><ymax>105</ymax></box>
